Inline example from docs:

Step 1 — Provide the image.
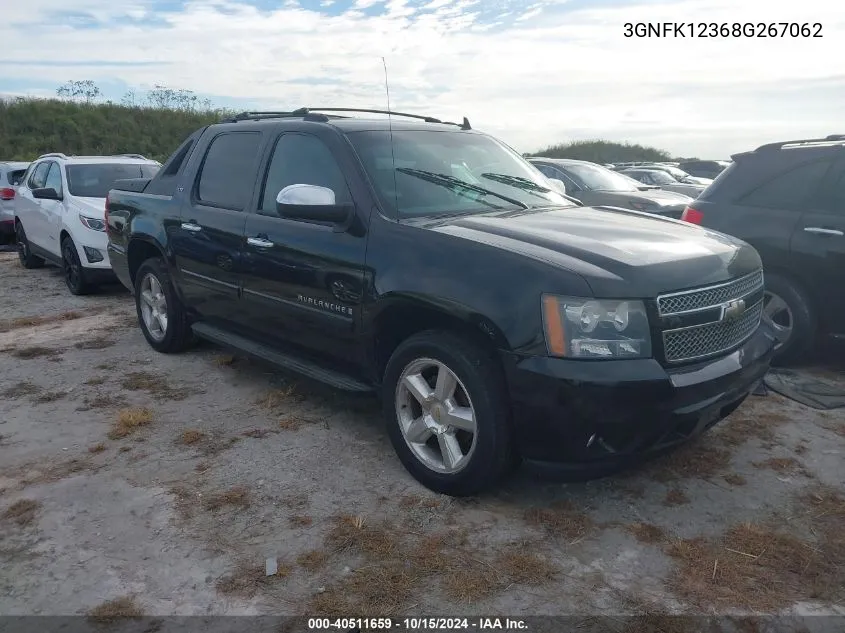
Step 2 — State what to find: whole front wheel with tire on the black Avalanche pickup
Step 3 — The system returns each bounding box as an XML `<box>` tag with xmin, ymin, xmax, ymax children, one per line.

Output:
<box><xmin>382</xmin><ymin>331</ymin><xmax>515</xmax><ymax>497</ymax></box>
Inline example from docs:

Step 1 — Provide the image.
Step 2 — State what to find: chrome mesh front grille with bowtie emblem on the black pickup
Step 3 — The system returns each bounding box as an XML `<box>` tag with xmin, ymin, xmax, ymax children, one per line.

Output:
<box><xmin>657</xmin><ymin>271</ymin><xmax>764</xmax><ymax>363</ymax></box>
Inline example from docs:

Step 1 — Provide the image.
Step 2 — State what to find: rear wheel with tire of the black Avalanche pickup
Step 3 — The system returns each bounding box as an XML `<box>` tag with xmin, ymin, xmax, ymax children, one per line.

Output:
<box><xmin>135</xmin><ymin>257</ymin><xmax>193</xmax><ymax>354</ymax></box>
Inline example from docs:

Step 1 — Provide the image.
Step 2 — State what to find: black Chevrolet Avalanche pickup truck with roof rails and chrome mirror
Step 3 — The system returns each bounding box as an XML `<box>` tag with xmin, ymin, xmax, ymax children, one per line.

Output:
<box><xmin>106</xmin><ymin>108</ymin><xmax>774</xmax><ymax>495</ymax></box>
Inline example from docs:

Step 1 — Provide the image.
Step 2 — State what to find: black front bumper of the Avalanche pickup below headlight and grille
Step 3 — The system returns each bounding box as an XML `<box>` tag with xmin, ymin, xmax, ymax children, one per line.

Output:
<box><xmin>503</xmin><ymin>323</ymin><xmax>775</xmax><ymax>469</ymax></box>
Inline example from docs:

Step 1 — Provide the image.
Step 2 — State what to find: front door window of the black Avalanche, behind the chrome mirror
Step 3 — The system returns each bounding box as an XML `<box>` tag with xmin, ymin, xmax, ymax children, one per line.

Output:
<box><xmin>259</xmin><ymin>134</ymin><xmax>352</xmax><ymax>215</ymax></box>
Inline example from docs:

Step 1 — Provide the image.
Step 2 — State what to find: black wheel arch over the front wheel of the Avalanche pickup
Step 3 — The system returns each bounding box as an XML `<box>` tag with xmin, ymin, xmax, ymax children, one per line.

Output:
<box><xmin>375</xmin><ymin>304</ymin><xmax>500</xmax><ymax>381</ymax></box>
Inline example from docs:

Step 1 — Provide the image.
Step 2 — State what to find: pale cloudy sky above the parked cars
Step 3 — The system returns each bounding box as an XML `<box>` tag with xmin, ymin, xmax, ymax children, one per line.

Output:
<box><xmin>0</xmin><ymin>0</ymin><xmax>845</xmax><ymax>158</ymax></box>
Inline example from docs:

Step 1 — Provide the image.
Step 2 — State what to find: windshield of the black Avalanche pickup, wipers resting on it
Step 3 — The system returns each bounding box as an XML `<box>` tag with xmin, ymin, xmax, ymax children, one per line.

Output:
<box><xmin>347</xmin><ymin>130</ymin><xmax>574</xmax><ymax>218</ymax></box>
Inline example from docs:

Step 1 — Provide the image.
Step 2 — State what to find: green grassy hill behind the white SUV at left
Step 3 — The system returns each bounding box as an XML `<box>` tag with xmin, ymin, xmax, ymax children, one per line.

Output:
<box><xmin>0</xmin><ymin>98</ymin><xmax>224</xmax><ymax>161</ymax></box>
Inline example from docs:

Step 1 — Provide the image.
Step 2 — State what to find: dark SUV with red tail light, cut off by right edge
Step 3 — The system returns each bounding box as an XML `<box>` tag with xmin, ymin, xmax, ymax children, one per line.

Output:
<box><xmin>682</xmin><ymin>135</ymin><xmax>845</xmax><ymax>362</ymax></box>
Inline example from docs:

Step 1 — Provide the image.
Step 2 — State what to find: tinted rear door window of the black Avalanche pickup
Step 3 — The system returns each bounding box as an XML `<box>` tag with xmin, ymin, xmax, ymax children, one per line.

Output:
<box><xmin>197</xmin><ymin>132</ymin><xmax>261</xmax><ymax>211</ymax></box>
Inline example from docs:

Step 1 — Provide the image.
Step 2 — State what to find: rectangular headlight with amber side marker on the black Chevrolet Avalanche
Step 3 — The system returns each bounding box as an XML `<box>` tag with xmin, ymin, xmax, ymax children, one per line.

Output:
<box><xmin>543</xmin><ymin>295</ymin><xmax>651</xmax><ymax>359</ymax></box>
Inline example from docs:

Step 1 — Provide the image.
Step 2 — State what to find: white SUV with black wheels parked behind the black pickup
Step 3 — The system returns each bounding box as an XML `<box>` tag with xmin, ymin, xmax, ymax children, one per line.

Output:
<box><xmin>15</xmin><ymin>154</ymin><xmax>161</xmax><ymax>295</ymax></box>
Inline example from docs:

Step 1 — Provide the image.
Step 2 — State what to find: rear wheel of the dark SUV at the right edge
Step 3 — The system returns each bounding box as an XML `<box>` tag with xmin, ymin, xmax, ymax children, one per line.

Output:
<box><xmin>763</xmin><ymin>273</ymin><xmax>816</xmax><ymax>365</ymax></box>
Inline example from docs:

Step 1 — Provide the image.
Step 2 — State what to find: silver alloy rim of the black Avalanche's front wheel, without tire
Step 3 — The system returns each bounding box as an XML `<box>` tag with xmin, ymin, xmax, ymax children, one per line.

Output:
<box><xmin>395</xmin><ymin>358</ymin><xmax>477</xmax><ymax>474</ymax></box>
